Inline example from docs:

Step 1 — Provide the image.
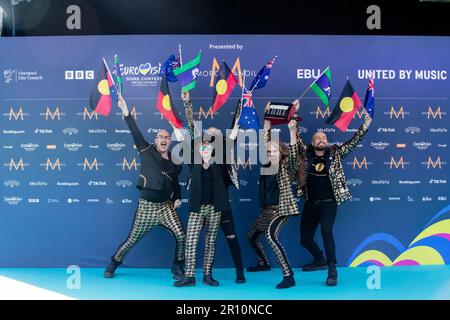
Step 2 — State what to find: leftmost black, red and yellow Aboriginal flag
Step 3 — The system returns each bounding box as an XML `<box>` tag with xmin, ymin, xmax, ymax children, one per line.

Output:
<box><xmin>89</xmin><ymin>58</ymin><xmax>118</xmax><ymax>116</ymax></box>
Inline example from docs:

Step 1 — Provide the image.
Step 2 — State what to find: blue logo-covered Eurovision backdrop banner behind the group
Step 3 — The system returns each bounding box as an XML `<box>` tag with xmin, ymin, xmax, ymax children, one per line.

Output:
<box><xmin>0</xmin><ymin>35</ymin><xmax>450</xmax><ymax>267</ymax></box>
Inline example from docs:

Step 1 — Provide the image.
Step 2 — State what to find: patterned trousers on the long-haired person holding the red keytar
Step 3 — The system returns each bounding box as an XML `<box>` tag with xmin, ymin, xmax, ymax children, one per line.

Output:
<box><xmin>246</xmin><ymin>206</ymin><xmax>293</xmax><ymax>276</ymax></box>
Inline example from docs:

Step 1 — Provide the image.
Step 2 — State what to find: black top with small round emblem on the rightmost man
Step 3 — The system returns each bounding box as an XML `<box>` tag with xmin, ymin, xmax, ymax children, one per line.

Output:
<box><xmin>306</xmin><ymin>156</ymin><xmax>334</xmax><ymax>201</ymax></box>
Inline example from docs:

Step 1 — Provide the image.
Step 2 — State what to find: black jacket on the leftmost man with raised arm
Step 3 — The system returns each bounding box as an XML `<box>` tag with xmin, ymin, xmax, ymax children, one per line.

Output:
<box><xmin>125</xmin><ymin>115</ymin><xmax>182</xmax><ymax>200</ymax></box>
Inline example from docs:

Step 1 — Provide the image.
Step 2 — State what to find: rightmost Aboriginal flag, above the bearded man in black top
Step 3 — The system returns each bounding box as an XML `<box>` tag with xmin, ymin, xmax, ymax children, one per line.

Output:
<box><xmin>326</xmin><ymin>80</ymin><xmax>362</xmax><ymax>132</ymax></box>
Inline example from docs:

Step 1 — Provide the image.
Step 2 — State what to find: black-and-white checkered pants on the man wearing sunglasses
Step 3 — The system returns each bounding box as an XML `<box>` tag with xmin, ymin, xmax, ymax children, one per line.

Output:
<box><xmin>185</xmin><ymin>205</ymin><xmax>221</xmax><ymax>277</ymax></box>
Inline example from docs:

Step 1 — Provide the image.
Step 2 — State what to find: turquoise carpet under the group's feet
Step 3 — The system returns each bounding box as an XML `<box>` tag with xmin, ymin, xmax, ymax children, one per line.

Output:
<box><xmin>0</xmin><ymin>266</ymin><xmax>450</xmax><ymax>300</ymax></box>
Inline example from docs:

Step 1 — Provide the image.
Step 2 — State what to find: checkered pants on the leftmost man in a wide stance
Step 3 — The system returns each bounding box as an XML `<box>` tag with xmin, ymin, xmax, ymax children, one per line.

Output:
<box><xmin>113</xmin><ymin>199</ymin><xmax>186</xmax><ymax>263</ymax></box>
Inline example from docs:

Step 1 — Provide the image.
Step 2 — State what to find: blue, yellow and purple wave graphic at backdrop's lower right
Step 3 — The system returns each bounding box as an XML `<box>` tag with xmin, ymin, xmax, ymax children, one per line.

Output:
<box><xmin>347</xmin><ymin>205</ymin><xmax>450</xmax><ymax>267</ymax></box>
